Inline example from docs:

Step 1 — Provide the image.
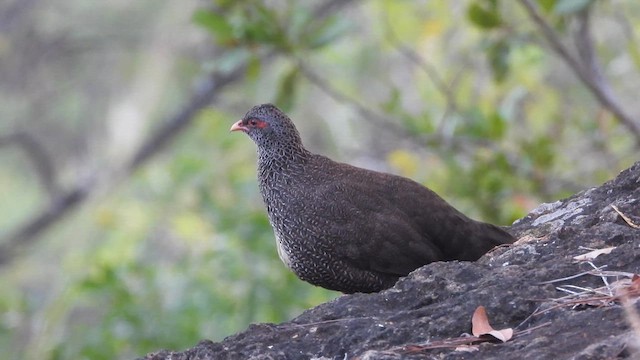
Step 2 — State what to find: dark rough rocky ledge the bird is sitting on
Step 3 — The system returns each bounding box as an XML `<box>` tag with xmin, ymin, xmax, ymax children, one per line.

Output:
<box><xmin>141</xmin><ymin>162</ymin><xmax>640</xmax><ymax>360</ymax></box>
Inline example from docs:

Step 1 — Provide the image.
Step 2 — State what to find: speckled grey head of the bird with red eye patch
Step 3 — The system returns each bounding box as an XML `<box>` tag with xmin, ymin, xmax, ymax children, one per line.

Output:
<box><xmin>229</xmin><ymin>104</ymin><xmax>302</xmax><ymax>150</ymax></box>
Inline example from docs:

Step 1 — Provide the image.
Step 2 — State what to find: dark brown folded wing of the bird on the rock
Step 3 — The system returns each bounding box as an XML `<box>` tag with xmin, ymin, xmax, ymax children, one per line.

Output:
<box><xmin>299</xmin><ymin>159</ymin><xmax>468</xmax><ymax>276</ymax></box>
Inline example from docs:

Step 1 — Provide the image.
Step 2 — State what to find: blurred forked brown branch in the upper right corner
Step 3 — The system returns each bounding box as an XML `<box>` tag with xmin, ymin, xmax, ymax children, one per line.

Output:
<box><xmin>519</xmin><ymin>0</ymin><xmax>640</xmax><ymax>147</ymax></box>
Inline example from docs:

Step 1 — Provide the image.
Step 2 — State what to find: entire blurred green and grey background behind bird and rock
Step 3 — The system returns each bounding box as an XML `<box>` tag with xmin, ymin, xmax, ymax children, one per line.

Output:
<box><xmin>0</xmin><ymin>0</ymin><xmax>640</xmax><ymax>359</ymax></box>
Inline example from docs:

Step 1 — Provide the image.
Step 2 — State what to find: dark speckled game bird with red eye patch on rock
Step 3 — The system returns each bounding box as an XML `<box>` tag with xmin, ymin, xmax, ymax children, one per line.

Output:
<box><xmin>230</xmin><ymin>104</ymin><xmax>515</xmax><ymax>294</ymax></box>
